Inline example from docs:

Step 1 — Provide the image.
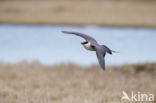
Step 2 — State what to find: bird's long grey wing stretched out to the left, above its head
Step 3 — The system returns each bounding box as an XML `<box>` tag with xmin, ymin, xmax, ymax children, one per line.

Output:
<box><xmin>62</xmin><ymin>31</ymin><xmax>97</xmax><ymax>42</ymax></box>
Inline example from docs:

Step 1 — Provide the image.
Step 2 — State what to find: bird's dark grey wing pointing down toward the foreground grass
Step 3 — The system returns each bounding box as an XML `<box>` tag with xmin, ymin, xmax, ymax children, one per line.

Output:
<box><xmin>96</xmin><ymin>48</ymin><xmax>106</xmax><ymax>70</ymax></box>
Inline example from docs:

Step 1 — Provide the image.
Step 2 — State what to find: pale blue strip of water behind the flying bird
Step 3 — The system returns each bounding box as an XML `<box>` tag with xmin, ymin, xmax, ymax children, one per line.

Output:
<box><xmin>0</xmin><ymin>24</ymin><xmax>156</xmax><ymax>66</ymax></box>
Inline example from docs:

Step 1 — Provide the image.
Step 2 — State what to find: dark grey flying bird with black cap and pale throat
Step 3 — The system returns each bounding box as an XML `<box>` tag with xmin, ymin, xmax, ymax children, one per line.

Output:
<box><xmin>62</xmin><ymin>31</ymin><xmax>116</xmax><ymax>70</ymax></box>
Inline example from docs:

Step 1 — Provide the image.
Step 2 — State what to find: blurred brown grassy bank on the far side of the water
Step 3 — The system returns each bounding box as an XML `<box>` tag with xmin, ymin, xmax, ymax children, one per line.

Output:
<box><xmin>0</xmin><ymin>0</ymin><xmax>156</xmax><ymax>27</ymax></box>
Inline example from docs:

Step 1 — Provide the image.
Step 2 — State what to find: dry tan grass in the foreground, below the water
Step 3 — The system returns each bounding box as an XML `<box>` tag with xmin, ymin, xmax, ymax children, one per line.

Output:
<box><xmin>0</xmin><ymin>63</ymin><xmax>156</xmax><ymax>103</ymax></box>
